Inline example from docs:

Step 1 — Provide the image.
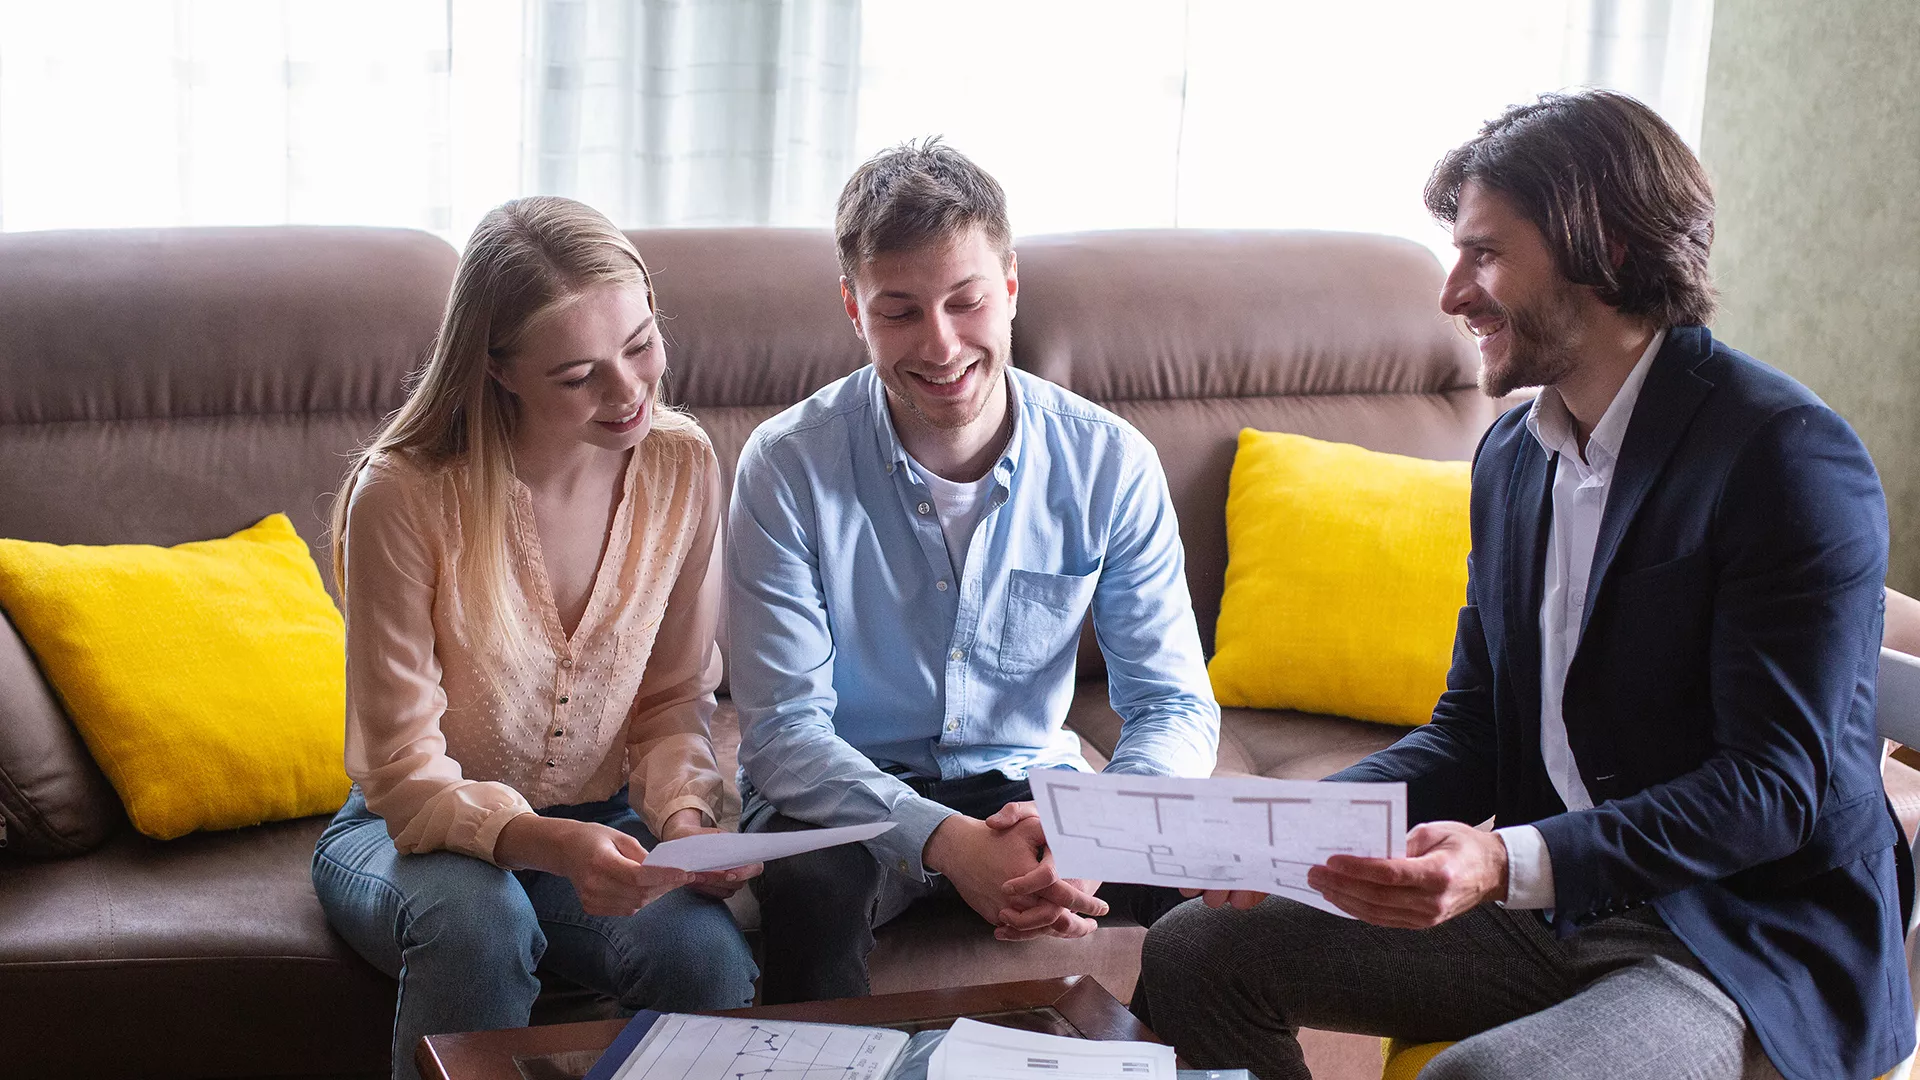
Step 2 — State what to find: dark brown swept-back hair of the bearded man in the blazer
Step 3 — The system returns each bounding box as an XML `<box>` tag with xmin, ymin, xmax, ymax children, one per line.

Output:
<box><xmin>1427</xmin><ymin>90</ymin><xmax>1715</xmax><ymax>327</ymax></box>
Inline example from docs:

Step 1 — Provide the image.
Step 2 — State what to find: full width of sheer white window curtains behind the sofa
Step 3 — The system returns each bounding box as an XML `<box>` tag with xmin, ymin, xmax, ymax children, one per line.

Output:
<box><xmin>0</xmin><ymin>0</ymin><xmax>1713</xmax><ymax>250</ymax></box>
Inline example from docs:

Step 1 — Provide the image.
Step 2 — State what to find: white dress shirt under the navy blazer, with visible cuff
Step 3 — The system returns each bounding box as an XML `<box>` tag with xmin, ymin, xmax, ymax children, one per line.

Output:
<box><xmin>1494</xmin><ymin>331</ymin><xmax>1667</xmax><ymax>909</ymax></box>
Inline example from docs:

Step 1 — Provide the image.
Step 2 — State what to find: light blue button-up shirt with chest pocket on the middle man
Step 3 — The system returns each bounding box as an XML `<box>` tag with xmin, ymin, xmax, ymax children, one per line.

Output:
<box><xmin>728</xmin><ymin>367</ymin><xmax>1219</xmax><ymax>878</ymax></box>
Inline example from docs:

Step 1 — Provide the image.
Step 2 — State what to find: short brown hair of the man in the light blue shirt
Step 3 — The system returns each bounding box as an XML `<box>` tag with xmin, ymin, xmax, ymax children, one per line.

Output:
<box><xmin>833</xmin><ymin>135</ymin><xmax>1014</xmax><ymax>281</ymax></box>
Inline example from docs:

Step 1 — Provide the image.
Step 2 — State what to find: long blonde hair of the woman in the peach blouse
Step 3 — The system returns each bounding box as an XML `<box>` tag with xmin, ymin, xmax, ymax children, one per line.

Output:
<box><xmin>332</xmin><ymin>196</ymin><xmax>695</xmax><ymax>669</ymax></box>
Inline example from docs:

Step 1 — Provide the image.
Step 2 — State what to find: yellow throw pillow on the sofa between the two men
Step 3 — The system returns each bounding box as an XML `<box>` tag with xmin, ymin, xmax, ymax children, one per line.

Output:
<box><xmin>1208</xmin><ymin>429</ymin><xmax>1471</xmax><ymax>724</ymax></box>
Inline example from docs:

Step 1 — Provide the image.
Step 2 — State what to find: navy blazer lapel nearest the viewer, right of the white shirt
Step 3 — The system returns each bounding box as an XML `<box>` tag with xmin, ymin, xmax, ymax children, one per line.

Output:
<box><xmin>1580</xmin><ymin>327</ymin><xmax>1713</xmax><ymax>640</ymax></box>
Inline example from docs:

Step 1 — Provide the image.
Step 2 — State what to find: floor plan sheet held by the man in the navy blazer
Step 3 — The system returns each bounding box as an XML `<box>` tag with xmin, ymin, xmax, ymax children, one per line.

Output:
<box><xmin>1027</xmin><ymin>769</ymin><xmax>1407</xmax><ymax>915</ymax></box>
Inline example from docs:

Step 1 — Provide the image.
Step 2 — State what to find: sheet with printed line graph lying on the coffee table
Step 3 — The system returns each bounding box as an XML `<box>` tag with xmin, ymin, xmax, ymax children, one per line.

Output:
<box><xmin>614</xmin><ymin>1013</ymin><xmax>906</xmax><ymax>1080</ymax></box>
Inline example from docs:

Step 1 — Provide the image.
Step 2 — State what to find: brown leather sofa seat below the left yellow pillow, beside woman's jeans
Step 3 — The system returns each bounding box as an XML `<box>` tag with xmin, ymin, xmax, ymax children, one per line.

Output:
<box><xmin>0</xmin><ymin>819</ymin><xmax>394</xmax><ymax>1078</ymax></box>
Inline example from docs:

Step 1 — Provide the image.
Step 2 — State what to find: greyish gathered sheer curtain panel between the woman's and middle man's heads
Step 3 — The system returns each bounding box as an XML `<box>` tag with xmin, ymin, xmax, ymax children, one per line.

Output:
<box><xmin>528</xmin><ymin>0</ymin><xmax>860</xmax><ymax>227</ymax></box>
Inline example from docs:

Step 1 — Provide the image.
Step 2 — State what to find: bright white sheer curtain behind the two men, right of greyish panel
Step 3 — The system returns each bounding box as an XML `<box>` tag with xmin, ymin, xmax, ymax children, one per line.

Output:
<box><xmin>858</xmin><ymin>0</ymin><xmax>1713</xmax><ymax>252</ymax></box>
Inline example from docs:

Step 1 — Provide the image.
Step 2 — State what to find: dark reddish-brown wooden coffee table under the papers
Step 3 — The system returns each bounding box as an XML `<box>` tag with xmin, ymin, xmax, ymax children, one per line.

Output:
<box><xmin>415</xmin><ymin>974</ymin><xmax>1160</xmax><ymax>1080</ymax></box>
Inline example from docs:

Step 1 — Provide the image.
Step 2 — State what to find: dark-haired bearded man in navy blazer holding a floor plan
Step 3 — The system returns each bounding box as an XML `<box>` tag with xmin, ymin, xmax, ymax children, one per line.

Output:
<box><xmin>1137</xmin><ymin>92</ymin><xmax>1914</xmax><ymax>1080</ymax></box>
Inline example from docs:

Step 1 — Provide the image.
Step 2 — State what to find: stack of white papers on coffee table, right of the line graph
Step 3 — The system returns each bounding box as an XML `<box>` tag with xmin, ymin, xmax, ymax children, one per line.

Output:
<box><xmin>927</xmin><ymin>1019</ymin><xmax>1175</xmax><ymax>1080</ymax></box>
